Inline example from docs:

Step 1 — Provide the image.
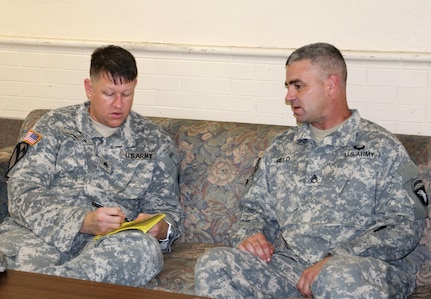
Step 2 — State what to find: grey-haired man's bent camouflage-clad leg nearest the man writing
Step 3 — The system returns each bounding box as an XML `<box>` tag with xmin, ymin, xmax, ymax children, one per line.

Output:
<box><xmin>195</xmin><ymin>247</ymin><xmax>302</xmax><ymax>298</ymax></box>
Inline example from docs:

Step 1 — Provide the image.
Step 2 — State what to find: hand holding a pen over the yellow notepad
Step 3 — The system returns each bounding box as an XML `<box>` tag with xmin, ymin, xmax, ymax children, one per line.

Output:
<box><xmin>79</xmin><ymin>207</ymin><xmax>126</xmax><ymax>235</ymax></box>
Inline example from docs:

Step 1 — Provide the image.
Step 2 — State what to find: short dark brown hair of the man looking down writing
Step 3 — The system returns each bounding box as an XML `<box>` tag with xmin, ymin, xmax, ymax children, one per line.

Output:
<box><xmin>90</xmin><ymin>45</ymin><xmax>138</xmax><ymax>84</ymax></box>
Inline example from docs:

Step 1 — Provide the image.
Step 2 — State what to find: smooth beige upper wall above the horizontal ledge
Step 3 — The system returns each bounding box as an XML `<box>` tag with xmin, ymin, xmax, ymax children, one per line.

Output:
<box><xmin>0</xmin><ymin>0</ymin><xmax>431</xmax><ymax>53</ymax></box>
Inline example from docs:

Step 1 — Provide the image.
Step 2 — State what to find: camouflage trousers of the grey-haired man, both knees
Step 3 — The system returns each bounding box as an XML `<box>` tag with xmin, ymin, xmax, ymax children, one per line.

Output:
<box><xmin>195</xmin><ymin>247</ymin><xmax>414</xmax><ymax>299</ymax></box>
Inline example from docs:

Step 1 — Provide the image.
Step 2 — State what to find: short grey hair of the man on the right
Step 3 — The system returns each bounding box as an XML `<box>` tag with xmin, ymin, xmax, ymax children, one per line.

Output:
<box><xmin>286</xmin><ymin>43</ymin><xmax>347</xmax><ymax>83</ymax></box>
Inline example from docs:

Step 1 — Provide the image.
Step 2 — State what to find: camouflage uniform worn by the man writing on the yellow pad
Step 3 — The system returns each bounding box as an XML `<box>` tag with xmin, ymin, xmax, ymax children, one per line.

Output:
<box><xmin>0</xmin><ymin>102</ymin><xmax>181</xmax><ymax>286</ymax></box>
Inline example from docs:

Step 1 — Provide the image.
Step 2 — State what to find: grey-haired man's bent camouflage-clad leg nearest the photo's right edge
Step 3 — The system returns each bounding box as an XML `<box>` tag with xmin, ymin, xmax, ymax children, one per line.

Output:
<box><xmin>312</xmin><ymin>256</ymin><xmax>411</xmax><ymax>298</ymax></box>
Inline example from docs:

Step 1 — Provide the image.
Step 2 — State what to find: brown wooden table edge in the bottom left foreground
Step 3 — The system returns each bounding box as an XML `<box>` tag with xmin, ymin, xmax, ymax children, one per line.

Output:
<box><xmin>0</xmin><ymin>269</ymin><xmax>207</xmax><ymax>299</ymax></box>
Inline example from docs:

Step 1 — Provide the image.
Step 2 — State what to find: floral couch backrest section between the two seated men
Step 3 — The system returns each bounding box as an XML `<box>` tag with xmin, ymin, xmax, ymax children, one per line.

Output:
<box><xmin>152</xmin><ymin>118</ymin><xmax>287</xmax><ymax>245</ymax></box>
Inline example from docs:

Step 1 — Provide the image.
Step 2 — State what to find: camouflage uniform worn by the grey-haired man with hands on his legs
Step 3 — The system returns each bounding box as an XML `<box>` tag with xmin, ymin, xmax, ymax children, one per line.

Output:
<box><xmin>195</xmin><ymin>110</ymin><xmax>429</xmax><ymax>298</ymax></box>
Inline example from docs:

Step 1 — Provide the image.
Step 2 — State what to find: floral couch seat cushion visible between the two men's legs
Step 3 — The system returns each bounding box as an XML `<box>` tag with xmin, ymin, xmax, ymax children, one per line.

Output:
<box><xmin>145</xmin><ymin>242</ymin><xmax>222</xmax><ymax>295</ymax></box>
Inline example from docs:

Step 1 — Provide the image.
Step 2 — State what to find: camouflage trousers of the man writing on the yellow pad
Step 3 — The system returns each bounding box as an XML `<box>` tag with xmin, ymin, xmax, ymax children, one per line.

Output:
<box><xmin>0</xmin><ymin>223</ymin><xmax>163</xmax><ymax>286</ymax></box>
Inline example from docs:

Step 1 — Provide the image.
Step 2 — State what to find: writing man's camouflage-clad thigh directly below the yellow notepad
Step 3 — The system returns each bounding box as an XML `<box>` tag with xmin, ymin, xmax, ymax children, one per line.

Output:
<box><xmin>44</xmin><ymin>230</ymin><xmax>163</xmax><ymax>286</ymax></box>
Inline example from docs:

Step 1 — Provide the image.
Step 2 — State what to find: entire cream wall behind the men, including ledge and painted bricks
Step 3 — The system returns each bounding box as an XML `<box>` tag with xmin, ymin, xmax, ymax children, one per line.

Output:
<box><xmin>0</xmin><ymin>0</ymin><xmax>431</xmax><ymax>135</ymax></box>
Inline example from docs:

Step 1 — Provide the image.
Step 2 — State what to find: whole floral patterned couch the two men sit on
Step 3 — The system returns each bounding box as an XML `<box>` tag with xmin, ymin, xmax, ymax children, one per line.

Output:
<box><xmin>0</xmin><ymin>110</ymin><xmax>431</xmax><ymax>298</ymax></box>
